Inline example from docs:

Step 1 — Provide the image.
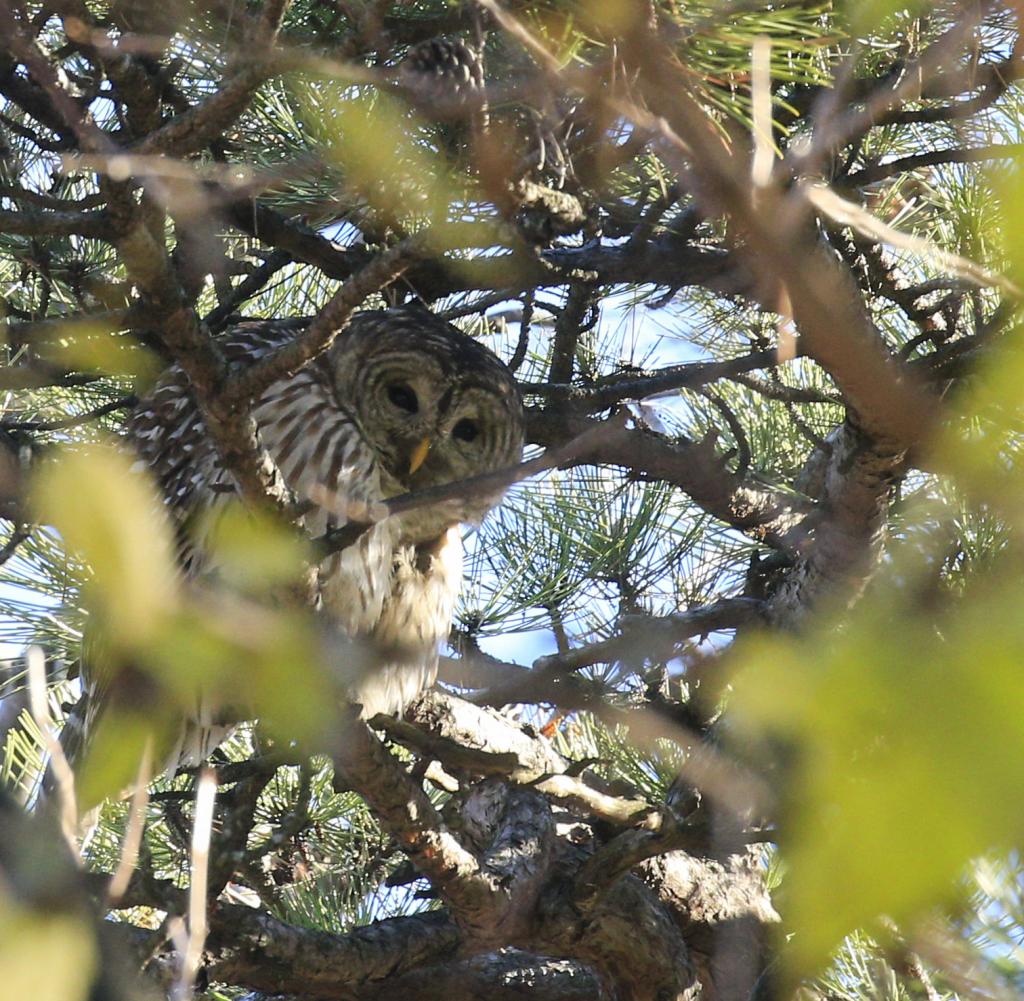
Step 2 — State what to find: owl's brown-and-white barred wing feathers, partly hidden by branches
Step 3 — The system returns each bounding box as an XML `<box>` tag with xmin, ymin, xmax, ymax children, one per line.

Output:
<box><xmin>99</xmin><ymin>320</ymin><xmax>387</xmax><ymax>749</ymax></box>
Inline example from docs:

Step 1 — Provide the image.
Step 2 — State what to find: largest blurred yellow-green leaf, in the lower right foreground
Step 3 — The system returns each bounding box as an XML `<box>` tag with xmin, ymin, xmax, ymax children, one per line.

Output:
<box><xmin>733</xmin><ymin>585</ymin><xmax>1024</xmax><ymax>975</ymax></box>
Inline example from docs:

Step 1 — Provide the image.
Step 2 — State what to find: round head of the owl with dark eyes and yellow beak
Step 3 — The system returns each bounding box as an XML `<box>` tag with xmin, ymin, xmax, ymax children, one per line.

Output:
<box><xmin>328</xmin><ymin>306</ymin><xmax>523</xmax><ymax>538</ymax></box>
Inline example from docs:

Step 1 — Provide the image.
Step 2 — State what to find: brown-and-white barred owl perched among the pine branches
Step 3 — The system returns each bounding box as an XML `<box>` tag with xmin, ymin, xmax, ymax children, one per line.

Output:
<box><xmin>128</xmin><ymin>308</ymin><xmax>523</xmax><ymax>720</ymax></box>
